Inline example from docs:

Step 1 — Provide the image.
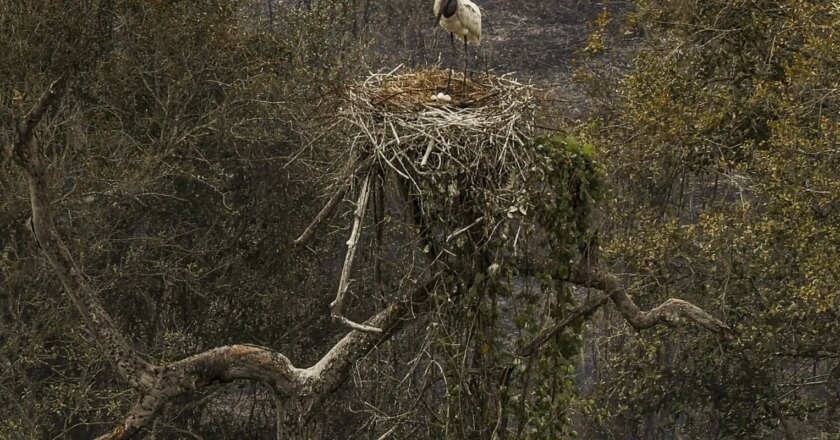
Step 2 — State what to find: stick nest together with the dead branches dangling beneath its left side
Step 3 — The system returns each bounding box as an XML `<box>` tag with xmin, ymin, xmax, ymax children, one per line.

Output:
<box><xmin>297</xmin><ymin>66</ymin><xmax>539</xmax><ymax>331</ymax></box>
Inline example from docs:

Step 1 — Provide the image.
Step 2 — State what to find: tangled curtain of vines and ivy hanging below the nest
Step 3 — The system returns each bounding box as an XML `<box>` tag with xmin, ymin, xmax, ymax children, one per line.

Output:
<box><xmin>374</xmin><ymin>129</ymin><xmax>603</xmax><ymax>439</ymax></box>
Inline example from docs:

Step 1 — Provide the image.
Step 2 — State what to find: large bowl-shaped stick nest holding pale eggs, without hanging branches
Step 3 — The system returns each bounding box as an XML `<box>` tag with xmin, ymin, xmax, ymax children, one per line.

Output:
<box><xmin>344</xmin><ymin>66</ymin><xmax>538</xmax><ymax>224</ymax></box>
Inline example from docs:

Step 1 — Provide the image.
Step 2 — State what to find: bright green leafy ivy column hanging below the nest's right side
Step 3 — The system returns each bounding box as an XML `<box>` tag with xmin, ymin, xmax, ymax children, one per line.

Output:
<box><xmin>508</xmin><ymin>135</ymin><xmax>603</xmax><ymax>439</ymax></box>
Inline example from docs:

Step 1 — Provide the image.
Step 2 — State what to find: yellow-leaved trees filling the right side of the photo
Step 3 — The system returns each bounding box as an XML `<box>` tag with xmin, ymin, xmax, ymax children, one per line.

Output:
<box><xmin>580</xmin><ymin>1</ymin><xmax>840</xmax><ymax>439</ymax></box>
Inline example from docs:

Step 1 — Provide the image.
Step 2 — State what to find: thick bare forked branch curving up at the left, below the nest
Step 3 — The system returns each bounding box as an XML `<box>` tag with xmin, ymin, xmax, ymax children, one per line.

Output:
<box><xmin>10</xmin><ymin>79</ymin><xmax>433</xmax><ymax>440</ymax></box>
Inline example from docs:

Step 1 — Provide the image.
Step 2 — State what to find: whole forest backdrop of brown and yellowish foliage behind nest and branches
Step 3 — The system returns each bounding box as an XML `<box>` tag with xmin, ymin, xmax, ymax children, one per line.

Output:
<box><xmin>0</xmin><ymin>0</ymin><xmax>840</xmax><ymax>440</ymax></box>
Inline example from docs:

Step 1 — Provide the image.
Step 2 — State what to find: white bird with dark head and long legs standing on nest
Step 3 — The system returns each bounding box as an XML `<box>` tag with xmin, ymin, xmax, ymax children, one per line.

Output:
<box><xmin>434</xmin><ymin>0</ymin><xmax>481</xmax><ymax>94</ymax></box>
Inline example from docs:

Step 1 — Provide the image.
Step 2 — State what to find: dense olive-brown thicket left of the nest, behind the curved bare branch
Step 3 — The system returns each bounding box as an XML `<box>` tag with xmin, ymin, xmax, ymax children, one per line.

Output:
<box><xmin>0</xmin><ymin>1</ymin><xmax>354</xmax><ymax>438</ymax></box>
